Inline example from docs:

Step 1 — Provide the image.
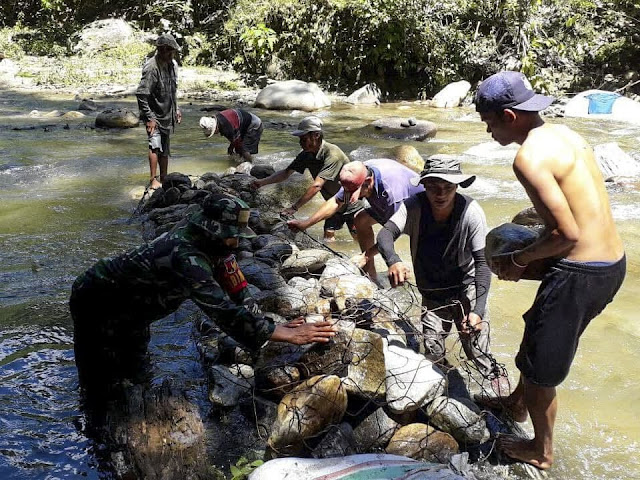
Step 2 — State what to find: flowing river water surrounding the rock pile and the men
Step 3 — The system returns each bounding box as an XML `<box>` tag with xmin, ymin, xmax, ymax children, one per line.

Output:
<box><xmin>0</xmin><ymin>91</ymin><xmax>640</xmax><ymax>480</ymax></box>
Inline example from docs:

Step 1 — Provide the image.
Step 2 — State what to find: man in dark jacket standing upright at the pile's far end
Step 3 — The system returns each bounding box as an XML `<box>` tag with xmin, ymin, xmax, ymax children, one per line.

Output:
<box><xmin>136</xmin><ymin>33</ymin><xmax>182</xmax><ymax>189</ymax></box>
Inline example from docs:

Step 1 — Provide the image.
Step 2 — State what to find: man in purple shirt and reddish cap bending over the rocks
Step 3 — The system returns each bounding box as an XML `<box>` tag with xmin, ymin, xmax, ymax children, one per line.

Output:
<box><xmin>287</xmin><ymin>158</ymin><xmax>424</xmax><ymax>280</ymax></box>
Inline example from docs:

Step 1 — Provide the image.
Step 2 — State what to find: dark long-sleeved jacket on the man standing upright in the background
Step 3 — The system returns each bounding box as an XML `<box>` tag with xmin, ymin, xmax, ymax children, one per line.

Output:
<box><xmin>136</xmin><ymin>55</ymin><xmax>178</xmax><ymax>133</ymax></box>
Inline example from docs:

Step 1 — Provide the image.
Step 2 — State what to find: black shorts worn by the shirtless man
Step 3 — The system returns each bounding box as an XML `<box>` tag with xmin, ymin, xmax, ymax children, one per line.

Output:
<box><xmin>516</xmin><ymin>256</ymin><xmax>626</xmax><ymax>387</ymax></box>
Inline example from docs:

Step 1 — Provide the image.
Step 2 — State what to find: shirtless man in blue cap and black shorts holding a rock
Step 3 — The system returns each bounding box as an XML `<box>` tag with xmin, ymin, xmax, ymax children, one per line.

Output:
<box><xmin>475</xmin><ymin>72</ymin><xmax>626</xmax><ymax>469</ymax></box>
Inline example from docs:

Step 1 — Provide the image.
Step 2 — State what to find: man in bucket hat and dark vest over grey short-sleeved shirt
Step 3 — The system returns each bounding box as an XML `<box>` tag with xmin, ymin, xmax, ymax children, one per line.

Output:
<box><xmin>354</xmin><ymin>155</ymin><xmax>509</xmax><ymax>395</ymax></box>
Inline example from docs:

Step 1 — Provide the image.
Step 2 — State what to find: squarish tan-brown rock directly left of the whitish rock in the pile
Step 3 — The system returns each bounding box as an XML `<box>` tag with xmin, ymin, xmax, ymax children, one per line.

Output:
<box><xmin>344</xmin><ymin>328</ymin><xmax>387</xmax><ymax>400</ymax></box>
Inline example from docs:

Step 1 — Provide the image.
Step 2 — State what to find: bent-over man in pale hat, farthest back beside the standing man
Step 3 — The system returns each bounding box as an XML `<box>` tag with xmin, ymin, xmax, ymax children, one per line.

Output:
<box><xmin>200</xmin><ymin>108</ymin><xmax>264</xmax><ymax>162</ymax></box>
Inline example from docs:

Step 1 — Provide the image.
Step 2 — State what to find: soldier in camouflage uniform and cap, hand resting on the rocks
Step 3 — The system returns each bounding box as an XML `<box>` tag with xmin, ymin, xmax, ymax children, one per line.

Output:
<box><xmin>70</xmin><ymin>194</ymin><xmax>335</xmax><ymax>392</ymax></box>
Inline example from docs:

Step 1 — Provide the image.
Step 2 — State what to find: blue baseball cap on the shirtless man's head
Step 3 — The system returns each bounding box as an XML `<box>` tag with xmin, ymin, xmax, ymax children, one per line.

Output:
<box><xmin>474</xmin><ymin>71</ymin><xmax>555</xmax><ymax>113</ymax></box>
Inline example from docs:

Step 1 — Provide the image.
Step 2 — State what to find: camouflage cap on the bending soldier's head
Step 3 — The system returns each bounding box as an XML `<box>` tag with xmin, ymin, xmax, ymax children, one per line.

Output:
<box><xmin>190</xmin><ymin>193</ymin><xmax>256</xmax><ymax>238</ymax></box>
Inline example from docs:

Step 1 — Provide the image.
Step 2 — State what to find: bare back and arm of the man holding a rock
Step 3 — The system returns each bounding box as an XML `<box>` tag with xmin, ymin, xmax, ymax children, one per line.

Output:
<box><xmin>513</xmin><ymin>123</ymin><xmax>624</xmax><ymax>262</ymax></box>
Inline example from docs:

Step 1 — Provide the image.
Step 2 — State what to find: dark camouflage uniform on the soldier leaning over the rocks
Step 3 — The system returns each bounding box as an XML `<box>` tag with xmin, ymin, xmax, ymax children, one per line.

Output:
<box><xmin>70</xmin><ymin>224</ymin><xmax>275</xmax><ymax>386</ymax></box>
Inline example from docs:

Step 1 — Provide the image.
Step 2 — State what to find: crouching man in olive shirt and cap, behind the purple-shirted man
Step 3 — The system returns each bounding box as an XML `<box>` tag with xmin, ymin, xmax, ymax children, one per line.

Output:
<box><xmin>253</xmin><ymin>116</ymin><xmax>364</xmax><ymax>242</ymax></box>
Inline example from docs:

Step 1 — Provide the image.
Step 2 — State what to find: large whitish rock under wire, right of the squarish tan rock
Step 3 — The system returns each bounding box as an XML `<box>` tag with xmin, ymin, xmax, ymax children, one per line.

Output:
<box><xmin>384</xmin><ymin>342</ymin><xmax>446</xmax><ymax>413</ymax></box>
